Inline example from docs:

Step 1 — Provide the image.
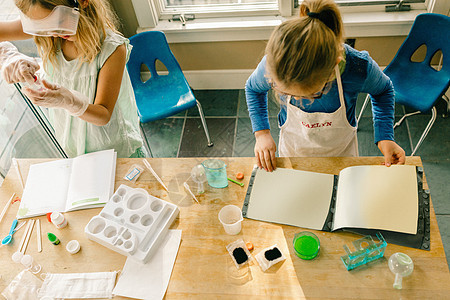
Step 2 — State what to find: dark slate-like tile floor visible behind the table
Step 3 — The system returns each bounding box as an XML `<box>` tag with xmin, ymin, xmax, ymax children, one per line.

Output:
<box><xmin>143</xmin><ymin>90</ymin><xmax>450</xmax><ymax>264</ymax></box>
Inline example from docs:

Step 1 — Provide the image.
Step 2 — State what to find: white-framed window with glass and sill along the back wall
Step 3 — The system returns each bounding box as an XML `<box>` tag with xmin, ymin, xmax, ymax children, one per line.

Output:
<box><xmin>131</xmin><ymin>0</ymin><xmax>444</xmax><ymax>38</ymax></box>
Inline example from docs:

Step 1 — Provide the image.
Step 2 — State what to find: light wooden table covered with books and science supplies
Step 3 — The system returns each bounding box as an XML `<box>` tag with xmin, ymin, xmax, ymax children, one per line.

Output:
<box><xmin>0</xmin><ymin>157</ymin><xmax>450</xmax><ymax>299</ymax></box>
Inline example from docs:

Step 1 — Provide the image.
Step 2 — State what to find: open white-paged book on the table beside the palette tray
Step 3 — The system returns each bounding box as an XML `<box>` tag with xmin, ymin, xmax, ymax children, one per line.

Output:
<box><xmin>17</xmin><ymin>149</ymin><xmax>117</xmax><ymax>219</ymax></box>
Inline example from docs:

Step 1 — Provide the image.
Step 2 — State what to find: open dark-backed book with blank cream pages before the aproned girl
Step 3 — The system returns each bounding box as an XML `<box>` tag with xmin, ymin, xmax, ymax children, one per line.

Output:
<box><xmin>243</xmin><ymin>165</ymin><xmax>429</xmax><ymax>248</ymax></box>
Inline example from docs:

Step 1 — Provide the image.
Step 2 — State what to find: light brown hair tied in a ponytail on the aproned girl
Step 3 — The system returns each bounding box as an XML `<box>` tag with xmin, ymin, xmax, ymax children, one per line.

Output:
<box><xmin>266</xmin><ymin>0</ymin><xmax>344</xmax><ymax>86</ymax></box>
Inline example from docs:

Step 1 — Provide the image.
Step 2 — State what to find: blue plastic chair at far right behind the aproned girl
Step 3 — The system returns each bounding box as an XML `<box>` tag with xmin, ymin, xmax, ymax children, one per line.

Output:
<box><xmin>358</xmin><ymin>13</ymin><xmax>450</xmax><ymax>156</ymax></box>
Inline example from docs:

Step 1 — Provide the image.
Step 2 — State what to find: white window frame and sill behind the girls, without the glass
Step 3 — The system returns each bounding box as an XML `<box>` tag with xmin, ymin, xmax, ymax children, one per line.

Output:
<box><xmin>131</xmin><ymin>0</ymin><xmax>450</xmax><ymax>39</ymax></box>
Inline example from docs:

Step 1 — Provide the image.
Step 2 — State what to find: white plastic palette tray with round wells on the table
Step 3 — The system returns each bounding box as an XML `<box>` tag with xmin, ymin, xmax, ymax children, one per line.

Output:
<box><xmin>84</xmin><ymin>184</ymin><xmax>179</xmax><ymax>263</ymax></box>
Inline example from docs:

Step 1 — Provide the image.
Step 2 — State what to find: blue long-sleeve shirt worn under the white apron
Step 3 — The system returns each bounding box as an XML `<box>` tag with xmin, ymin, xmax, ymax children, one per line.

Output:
<box><xmin>245</xmin><ymin>44</ymin><xmax>394</xmax><ymax>143</ymax></box>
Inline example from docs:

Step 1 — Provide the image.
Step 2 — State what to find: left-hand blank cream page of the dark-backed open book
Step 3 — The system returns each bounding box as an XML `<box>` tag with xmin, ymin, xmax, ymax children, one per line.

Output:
<box><xmin>247</xmin><ymin>168</ymin><xmax>334</xmax><ymax>230</ymax></box>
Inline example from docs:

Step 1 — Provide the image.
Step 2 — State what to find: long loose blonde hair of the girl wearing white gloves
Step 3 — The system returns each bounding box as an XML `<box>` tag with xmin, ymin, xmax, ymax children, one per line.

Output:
<box><xmin>15</xmin><ymin>0</ymin><xmax>117</xmax><ymax>67</ymax></box>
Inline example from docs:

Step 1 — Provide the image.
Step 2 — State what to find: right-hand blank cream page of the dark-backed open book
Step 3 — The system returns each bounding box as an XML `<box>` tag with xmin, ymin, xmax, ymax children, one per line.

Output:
<box><xmin>333</xmin><ymin>165</ymin><xmax>419</xmax><ymax>234</ymax></box>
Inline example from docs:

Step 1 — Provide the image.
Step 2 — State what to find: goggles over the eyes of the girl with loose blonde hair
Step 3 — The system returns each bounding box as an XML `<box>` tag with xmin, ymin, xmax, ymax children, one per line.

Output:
<box><xmin>20</xmin><ymin>1</ymin><xmax>80</xmax><ymax>36</ymax></box>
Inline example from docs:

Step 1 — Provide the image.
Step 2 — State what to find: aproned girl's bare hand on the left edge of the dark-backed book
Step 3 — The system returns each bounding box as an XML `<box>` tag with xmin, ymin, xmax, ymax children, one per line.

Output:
<box><xmin>255</xmin><ymin>129</ymin><xmax>277</xmax><ymax>172</ymax></box>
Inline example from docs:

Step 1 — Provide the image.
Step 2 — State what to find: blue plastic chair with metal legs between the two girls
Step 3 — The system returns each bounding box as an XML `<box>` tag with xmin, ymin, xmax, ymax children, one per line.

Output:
<box><xmin>127</xmin><ymin>31</ymin><xmax>213</xmax><ymax>155</ymax></box>
